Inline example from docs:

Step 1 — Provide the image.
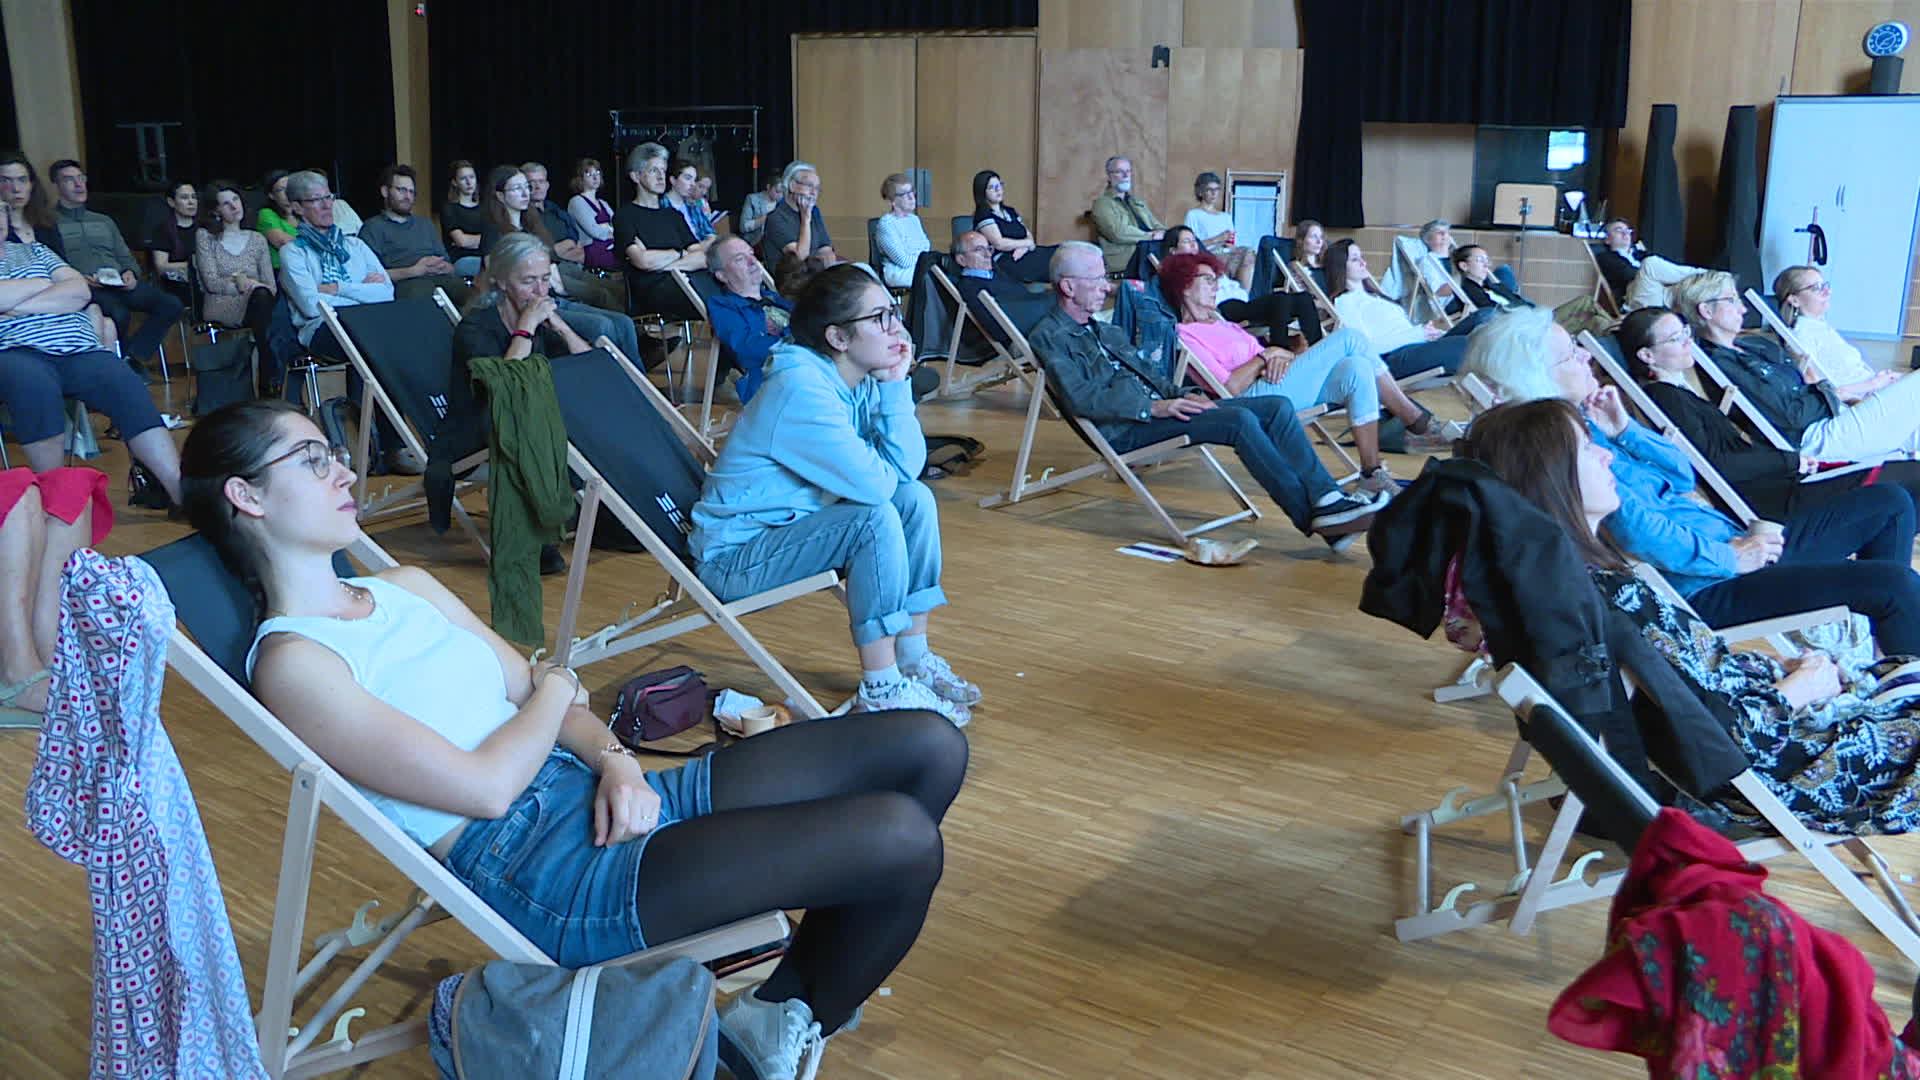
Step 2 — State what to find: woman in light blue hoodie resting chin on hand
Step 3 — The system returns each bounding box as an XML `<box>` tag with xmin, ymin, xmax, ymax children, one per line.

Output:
<box><xmin>689</xmin><ymin>263</ymin><xmax>979</xmax><ymax>724</ymax></box>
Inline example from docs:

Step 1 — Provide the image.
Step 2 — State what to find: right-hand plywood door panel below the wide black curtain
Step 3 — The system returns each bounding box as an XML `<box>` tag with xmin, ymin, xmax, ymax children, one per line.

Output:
<box><xmin>913</xmin><ymin>35</ymin><xmax>1039</xmax><ymax>236</ymax></box>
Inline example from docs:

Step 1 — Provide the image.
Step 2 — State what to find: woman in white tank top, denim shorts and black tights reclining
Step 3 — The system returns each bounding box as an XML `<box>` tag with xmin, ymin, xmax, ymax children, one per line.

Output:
<box><xmin>182</xmin><ymin>400</ymin><xmax>968</xmax><ymax>1080</ymax></box>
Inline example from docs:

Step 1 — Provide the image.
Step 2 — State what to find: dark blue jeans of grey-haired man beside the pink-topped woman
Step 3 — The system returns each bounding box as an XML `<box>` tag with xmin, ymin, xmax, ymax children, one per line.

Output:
<box><xmin>1108</xmin><ymin>396</ymin><xmax>1340</xmax><ymax>532</ymax></box>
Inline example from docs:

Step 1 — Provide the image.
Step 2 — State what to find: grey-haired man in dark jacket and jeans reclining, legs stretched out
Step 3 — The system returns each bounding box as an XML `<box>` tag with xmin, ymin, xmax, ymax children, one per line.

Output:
<box><xmin>1027</xmin><ymin>240</ymin><xmax>1386</xmax><ymax>550</ymax></box>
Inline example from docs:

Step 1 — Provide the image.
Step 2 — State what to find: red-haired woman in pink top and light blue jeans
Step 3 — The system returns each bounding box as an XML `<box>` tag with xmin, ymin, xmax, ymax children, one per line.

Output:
<box><xmin>1160</xmin><ymin>252</ymin><xmax>1450</xmax><ymax>494</ymax></box>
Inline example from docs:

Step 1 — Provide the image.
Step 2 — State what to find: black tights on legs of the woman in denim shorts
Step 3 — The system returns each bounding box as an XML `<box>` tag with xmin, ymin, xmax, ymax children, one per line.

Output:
<box><xmin>639</xmin><ymin>713</ymin><xmax>968</xmax><ymax>1034</ymax></box>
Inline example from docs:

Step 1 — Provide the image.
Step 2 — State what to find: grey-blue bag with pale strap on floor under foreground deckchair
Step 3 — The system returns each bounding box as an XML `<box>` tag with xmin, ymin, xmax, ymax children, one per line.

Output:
<box><xmin>428</xmin><ymin>957</ymin><xmax>720</xmax><ymax>1080</ymax></box>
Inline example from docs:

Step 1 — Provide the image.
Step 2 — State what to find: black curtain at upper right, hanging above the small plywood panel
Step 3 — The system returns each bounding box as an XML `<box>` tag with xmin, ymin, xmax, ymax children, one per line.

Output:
<box><xmin>1292</xmin><ymin>0</ymin><xmax>1632</xmax><ymax>227</ymax></box>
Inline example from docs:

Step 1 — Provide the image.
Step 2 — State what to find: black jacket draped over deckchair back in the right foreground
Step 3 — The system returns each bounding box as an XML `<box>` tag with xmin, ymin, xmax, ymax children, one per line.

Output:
<box><xmin>1359</xmin><ymin>459</ymin><xmax>1747</xmax><ymax>818</ymax></box>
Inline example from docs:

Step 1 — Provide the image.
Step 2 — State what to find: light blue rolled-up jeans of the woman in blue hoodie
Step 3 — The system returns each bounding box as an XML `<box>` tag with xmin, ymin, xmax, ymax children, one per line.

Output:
<box><xmin>699</xmin><ymin>480</ymin><xmax>947</xmax><ymax>646</ymax></box>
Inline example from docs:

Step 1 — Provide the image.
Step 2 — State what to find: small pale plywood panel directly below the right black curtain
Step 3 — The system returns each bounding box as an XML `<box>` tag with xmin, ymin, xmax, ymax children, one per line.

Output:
<box><xmin>1359</xmin><ymin>123</ymin><xmax>1475</xmax><ymax>225</ymax></box>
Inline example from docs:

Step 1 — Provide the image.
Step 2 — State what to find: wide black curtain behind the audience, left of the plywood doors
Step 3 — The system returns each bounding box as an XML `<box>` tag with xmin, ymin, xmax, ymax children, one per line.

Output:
<box><xmin>432</xmin><ymin>0</ymin><xmax>1039</xmax><ymax>211</ymax></box>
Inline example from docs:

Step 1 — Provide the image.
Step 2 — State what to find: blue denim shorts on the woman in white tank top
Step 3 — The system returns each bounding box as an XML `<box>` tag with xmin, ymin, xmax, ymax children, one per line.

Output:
<box><xmin>447</xmin><ymin>751</ymin><xmax>712</xmax><ymax>967</ymax></box>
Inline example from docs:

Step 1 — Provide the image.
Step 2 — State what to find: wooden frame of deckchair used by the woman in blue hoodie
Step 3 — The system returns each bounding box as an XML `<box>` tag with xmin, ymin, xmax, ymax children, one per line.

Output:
<box><xmin>553</xmin><ymin>346</ymin><xmax>845</xmax><ymax>719</ymax></box>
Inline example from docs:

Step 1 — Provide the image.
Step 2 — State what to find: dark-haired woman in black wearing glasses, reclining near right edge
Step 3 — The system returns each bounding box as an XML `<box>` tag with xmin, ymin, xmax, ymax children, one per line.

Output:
<box><xmin>1615</xmin><ymin>307</ymin><xmax>1920</xmax><ymax>521</ymax></box>
